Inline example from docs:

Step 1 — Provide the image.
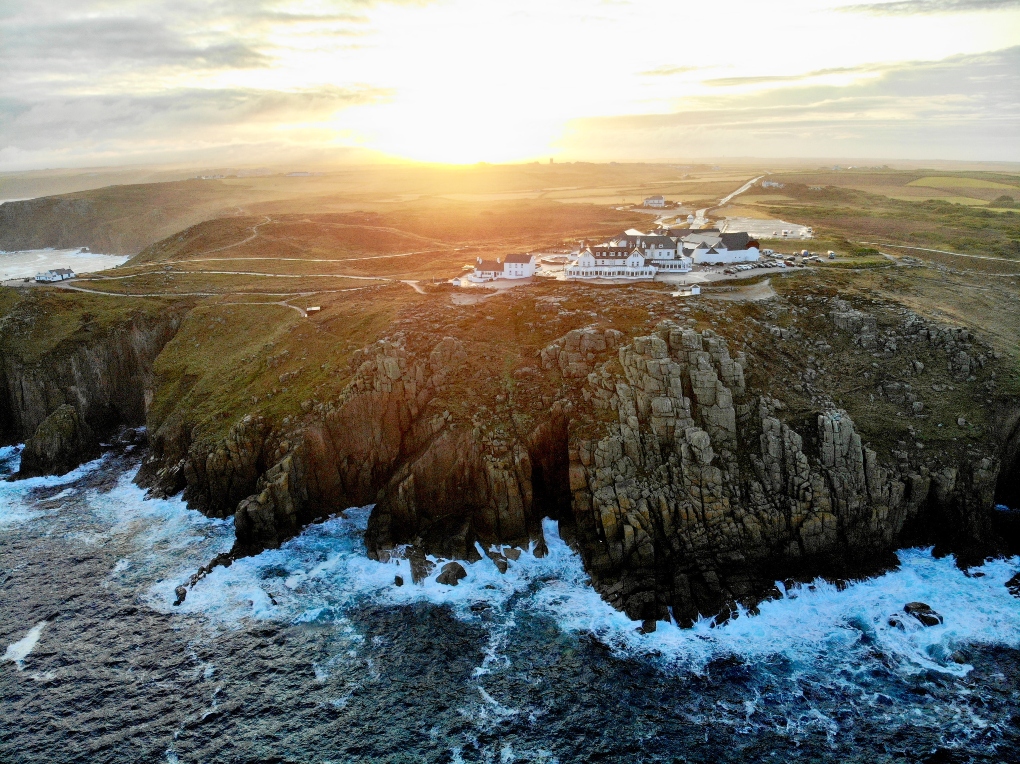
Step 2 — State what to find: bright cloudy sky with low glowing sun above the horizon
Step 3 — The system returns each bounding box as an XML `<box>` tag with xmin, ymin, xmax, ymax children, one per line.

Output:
<box><xmin>0</xmin><ymin>0</ymin><xmax>1020</xmax><ymax>170</ymax></box>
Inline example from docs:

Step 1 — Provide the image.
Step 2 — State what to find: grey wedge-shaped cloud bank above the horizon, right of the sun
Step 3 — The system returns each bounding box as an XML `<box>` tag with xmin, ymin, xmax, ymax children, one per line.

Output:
<box><xmin>562</xmin><ymin>47</ymin><xmax>1020</xmax><ymax>161</ymax></box>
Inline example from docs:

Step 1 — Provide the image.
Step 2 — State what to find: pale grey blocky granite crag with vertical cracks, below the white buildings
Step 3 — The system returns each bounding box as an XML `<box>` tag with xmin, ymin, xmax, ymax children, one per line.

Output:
<box><xmin>570</xmin><ymin>322</ymin><xmax>998</xmax><ymax>623</ymax></box>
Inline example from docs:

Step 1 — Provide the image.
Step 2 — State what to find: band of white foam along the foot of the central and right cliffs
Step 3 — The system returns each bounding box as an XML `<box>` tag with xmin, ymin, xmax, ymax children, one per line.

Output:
<box><xmin>159</xmin><ymin>508</ymin><xmax>1020</xmax><ymax>676</ymax></box>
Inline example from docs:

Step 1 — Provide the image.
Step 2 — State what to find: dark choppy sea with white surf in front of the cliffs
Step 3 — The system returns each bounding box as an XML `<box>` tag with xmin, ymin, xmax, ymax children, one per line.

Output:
<box><xmin>0</xmin><ymin>449</ymin><xmax>1020</xmax><ymax>764</ymax></box>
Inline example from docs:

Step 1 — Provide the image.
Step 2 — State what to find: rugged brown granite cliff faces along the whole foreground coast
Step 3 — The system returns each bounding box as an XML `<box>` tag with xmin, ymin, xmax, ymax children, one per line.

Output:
<box><xmin>4</xmin><ymin>281</ymin><xmax>1020</xmax><ymax>627</ymax></box>
